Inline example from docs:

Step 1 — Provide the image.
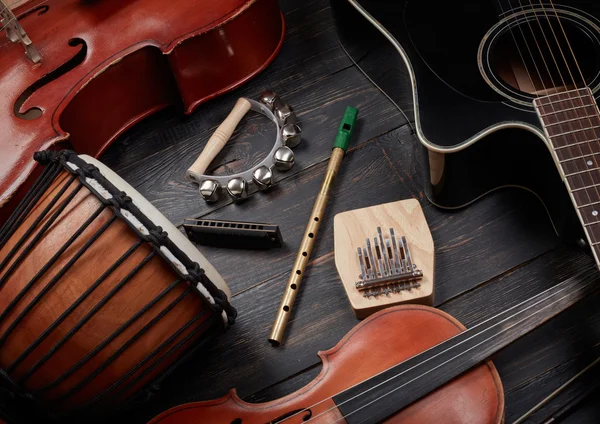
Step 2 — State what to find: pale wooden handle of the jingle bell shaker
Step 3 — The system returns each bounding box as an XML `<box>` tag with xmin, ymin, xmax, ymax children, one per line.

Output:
<box><xmin>185</xmin><ymin>97</ymin><xmax>252</xmax><ymax>182</ymax></box>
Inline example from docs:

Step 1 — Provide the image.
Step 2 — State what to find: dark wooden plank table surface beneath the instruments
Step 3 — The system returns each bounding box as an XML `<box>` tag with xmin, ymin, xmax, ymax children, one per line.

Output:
<box><xmin>101</xmin><ymin>0</ymin><xmax>600</xmax><ymax>423</ymax></box>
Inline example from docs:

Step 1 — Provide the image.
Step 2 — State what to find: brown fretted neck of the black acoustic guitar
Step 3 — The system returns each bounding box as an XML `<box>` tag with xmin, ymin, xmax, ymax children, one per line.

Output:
<box><xmin>534</xmin><ymin>87</ymin><xmax>600</xmax><ymax>267</ymax></box>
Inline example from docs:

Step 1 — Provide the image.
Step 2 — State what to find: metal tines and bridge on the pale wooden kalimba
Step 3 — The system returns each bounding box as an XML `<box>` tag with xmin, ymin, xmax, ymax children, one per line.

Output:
<box><xmin>355</xmin><ymin>227</ymin><xmax>423</xmax><ymax>297</ymax></box>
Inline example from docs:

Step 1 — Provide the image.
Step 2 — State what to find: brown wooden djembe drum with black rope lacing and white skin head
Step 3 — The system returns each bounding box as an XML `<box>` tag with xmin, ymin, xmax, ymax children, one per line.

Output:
<box><xmin>0</xmin><ymin>151</ymin><xmax>235</xmax><ymax>422</ymax></box>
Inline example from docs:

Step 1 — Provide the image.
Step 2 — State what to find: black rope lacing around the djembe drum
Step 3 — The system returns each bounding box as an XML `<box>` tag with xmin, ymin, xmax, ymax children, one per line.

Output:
<box><xmin>0</xmin><ymin>151</ymin><xmax>237</xmax><ymax>416</ymax></box>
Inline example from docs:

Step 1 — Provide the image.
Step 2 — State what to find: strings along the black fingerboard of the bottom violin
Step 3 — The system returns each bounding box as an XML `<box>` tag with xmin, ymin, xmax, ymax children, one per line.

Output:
<box><xmin>305</xmin><ymin>274</ymin><xmax>591</xmax><ymax>423</ymax></box>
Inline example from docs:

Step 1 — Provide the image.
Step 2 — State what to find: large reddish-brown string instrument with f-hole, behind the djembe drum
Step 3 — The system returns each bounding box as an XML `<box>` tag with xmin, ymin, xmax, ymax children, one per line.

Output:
<box><xmin>0</xmin><ymin>0</ymin><xmax>285</xmax><ymax>217</ymax></box>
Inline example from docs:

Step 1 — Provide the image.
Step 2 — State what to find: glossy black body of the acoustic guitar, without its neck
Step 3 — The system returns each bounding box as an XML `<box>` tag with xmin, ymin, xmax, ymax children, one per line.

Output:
<box><xmin>332</xmin><ymin>0</ymin><xmax>600</xmax><ymax>239</ymax></box>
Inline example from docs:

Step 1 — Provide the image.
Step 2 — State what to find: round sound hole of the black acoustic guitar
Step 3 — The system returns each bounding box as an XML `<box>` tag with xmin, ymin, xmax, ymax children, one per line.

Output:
<box><xmin>489</xmin><ymin>11</ymin><xmax>600</xmax><ymax>96</ymax></box>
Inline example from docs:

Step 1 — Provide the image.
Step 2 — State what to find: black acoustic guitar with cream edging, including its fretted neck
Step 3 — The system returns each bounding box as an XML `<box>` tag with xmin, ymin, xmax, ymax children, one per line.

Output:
<box><xmin>332</xmin><ymin>0</ymin><xmax>600</xmax><ymax>263</ymax></box>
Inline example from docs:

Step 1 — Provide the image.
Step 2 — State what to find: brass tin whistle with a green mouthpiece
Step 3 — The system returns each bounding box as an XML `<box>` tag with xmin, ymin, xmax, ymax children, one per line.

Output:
<box><xmin>269</xmin><ymin>106</ymin><xmax>358</xmax><ymax>346</ymax></box>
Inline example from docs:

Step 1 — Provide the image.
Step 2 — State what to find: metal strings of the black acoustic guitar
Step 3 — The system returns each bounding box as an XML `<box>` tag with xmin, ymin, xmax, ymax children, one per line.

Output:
<box><xmin>532</xmin><ymin>0</ymin><xmax>600</xmax><ymax>238</ymax></box>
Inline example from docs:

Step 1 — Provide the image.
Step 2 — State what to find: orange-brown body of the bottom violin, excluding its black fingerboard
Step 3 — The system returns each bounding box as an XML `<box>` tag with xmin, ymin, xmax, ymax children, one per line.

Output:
<box><xmin>151</xmin><ymin>305</ymin><xmax>504</xmax><ymax>424</ymax></box>
